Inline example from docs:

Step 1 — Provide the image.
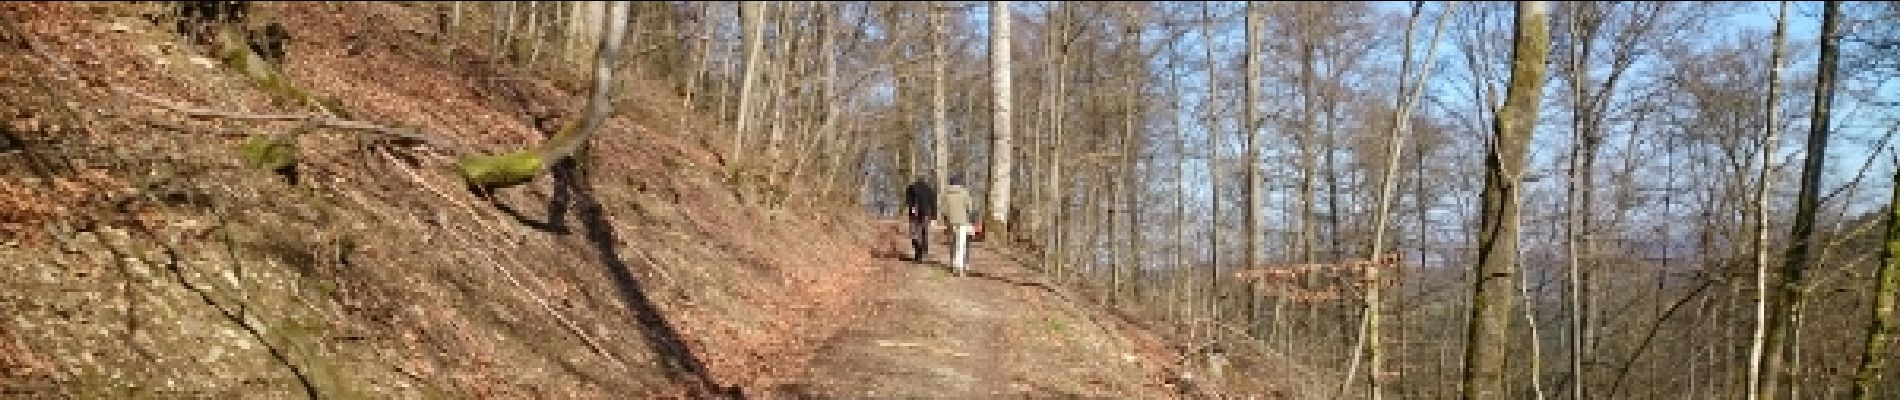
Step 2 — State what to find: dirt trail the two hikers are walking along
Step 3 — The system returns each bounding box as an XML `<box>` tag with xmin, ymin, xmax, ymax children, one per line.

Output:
<box><xmin>756</xmin><ymin>222</ymin><xmax>1180</xmax><ymax>398</ymax></box>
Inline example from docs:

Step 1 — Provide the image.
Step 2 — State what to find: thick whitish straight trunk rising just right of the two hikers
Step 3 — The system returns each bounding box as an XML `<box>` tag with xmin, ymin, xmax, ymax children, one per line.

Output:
<box><xmin>982</xmin><ymin>0</ymin><xmax>1015</xmax><ymax>239</ymax></box>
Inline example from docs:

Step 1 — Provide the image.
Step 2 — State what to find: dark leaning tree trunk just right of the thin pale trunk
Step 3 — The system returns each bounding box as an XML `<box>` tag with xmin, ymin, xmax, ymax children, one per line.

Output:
<box><xmin>1759</xmin><ymin>2</ymin><xmax>1841</xmax><ymax>398</ymax></box>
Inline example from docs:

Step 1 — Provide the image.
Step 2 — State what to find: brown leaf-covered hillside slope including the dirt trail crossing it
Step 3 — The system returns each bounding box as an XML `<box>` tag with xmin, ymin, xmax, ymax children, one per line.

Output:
<box><xmin>0</xmin><ymin>2</ymin><xmax>1246</xmax><ymax>398</ymax></box>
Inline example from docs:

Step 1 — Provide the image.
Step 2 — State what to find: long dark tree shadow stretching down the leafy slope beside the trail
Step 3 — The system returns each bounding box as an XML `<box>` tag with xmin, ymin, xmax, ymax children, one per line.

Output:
<box><xmin>549</xmin><ymin>150</ymin><xmax>743</xmax><ymax>398</ymax></box>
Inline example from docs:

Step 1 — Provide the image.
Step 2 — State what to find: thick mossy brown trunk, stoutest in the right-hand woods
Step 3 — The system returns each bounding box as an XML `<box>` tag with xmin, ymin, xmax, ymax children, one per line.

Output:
<box><xmin>1463</xmin><ymin>2</ymin><xmax>1550</xmax><ymax>398</ymax></box>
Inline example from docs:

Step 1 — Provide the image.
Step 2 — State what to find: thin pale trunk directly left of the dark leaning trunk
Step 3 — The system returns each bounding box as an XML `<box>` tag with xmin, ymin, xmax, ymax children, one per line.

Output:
<box><xmin>1744</xmin><ymin>0</ymin><xmax>1788</xmax><ymax>400</ymax></box>
